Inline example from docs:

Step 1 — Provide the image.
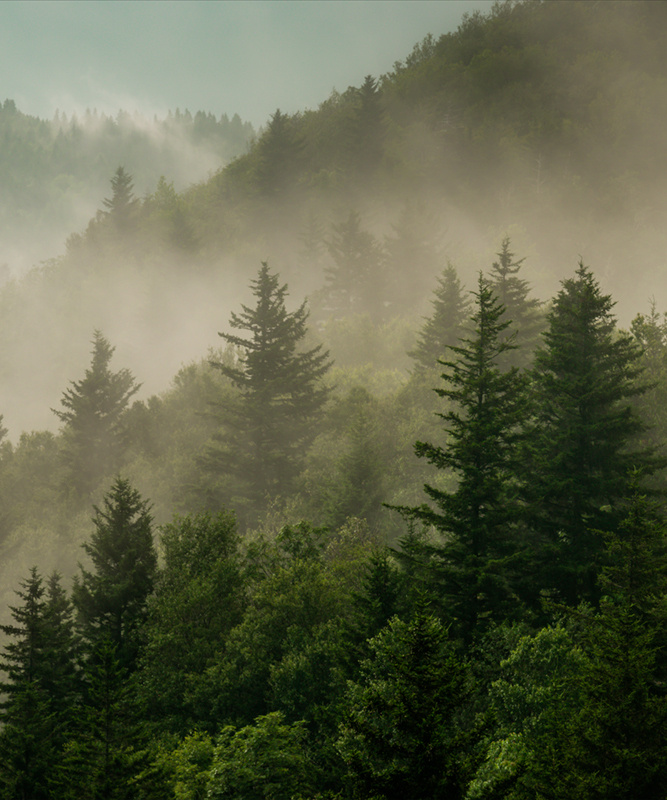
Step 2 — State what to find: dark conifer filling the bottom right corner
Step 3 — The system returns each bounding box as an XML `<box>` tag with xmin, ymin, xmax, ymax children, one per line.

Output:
<box><xmin>554</xmin><ymin>482</ymin><xmax>667</xmax><ymax>800</ymax></box>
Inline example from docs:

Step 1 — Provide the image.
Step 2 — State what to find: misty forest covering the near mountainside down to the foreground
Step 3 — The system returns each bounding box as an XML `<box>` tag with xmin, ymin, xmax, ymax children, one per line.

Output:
<box><xmin>0</xmin><ymin>0</ymin><xmax>667</xmax><ymax>800</ymax></box>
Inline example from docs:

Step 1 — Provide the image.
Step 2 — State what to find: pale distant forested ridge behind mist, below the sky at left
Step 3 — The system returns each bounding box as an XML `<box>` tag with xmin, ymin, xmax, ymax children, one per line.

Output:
<box><xmin>0</xmin><ymin>100</ymin><xmax>254</xmax><ymax>282</ymax></box>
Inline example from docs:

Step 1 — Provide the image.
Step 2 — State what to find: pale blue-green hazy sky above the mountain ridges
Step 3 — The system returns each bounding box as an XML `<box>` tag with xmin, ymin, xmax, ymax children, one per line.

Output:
<box><xmin>0</xmin><ymin>0</ymin><xmax>492</xmax><ymax>126</ymax></box>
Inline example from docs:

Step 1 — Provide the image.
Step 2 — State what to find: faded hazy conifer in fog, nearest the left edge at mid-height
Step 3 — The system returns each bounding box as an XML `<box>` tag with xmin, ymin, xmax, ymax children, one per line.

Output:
<box><xmin>53</xmin><ymin>331</ymin><xmax>140</xmax><ymax>497</ymax></box>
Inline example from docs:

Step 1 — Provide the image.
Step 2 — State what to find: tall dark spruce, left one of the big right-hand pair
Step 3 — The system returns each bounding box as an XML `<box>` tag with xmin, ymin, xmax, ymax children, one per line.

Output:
<box><xmin>399</xmin><ymin>273</ymin><xmax>526</xmax><ymax>640</ymax></box>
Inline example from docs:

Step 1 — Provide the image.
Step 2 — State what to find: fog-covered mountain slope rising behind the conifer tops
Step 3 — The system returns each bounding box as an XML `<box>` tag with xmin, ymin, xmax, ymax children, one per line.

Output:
<box><xmin>0</xmin><ymin>2</ymin><xmax>667</xmax><ymax>433</ymax></box>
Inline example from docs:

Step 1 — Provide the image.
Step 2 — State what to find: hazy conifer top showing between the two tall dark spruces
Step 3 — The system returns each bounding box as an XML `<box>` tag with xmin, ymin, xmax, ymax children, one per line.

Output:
<box><xmin>490</xmin><ymin>236</ymin><xmax>543</xmax><ymax>367</ymax></box>
